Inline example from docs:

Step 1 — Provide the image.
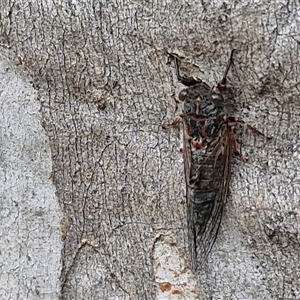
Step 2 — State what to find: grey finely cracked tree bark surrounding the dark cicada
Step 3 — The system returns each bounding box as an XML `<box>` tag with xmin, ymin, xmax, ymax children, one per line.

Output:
<box><xmin>0</xmin><ymin>0</ymin><xmax>300</xmax><ymax>300</ymax></box>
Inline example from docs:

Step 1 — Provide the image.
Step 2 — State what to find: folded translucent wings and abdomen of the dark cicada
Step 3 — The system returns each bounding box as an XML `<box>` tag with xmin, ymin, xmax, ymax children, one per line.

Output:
<box><xmin>185</xmin><ymin>126</ymin><xmax>232</xmax><ymax>272</ymax></box>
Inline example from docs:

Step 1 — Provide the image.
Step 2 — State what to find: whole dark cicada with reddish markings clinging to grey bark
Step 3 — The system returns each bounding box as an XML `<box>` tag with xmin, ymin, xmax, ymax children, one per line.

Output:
<box><xmin>163</xmin><ymin>50</ymin><xmax>271</xmax><ymax>272</ymax></box>
